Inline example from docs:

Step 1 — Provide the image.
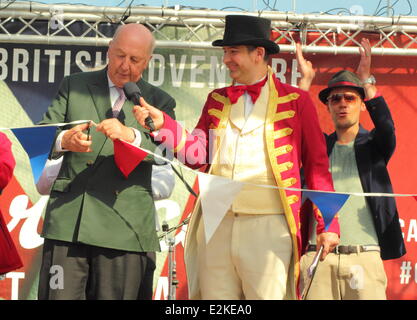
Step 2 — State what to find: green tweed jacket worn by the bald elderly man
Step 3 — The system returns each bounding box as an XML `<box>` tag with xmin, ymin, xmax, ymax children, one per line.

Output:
<box><xmin>40</xmin><ymin>69</ymin><xmax>175</xmax><ymax>252</ymax></box>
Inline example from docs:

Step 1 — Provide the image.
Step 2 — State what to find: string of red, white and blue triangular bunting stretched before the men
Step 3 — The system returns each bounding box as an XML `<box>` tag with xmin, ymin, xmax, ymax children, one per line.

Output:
<box><xmin>4</xmin><ymin>124</ymin><xmax>417</xmax><ymax>242</ymax></box>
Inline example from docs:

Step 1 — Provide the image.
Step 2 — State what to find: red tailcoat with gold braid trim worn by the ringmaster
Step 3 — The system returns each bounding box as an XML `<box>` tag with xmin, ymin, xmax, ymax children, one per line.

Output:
<box><xmin>160</xmin><ymin>71</ymin><xmax>339</xmax><ymax>298</ymax></box>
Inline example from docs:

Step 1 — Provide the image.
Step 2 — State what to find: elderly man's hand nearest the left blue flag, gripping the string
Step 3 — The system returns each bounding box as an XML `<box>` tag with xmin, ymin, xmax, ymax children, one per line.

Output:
<box><xmin>61</xmin><ymin>123</ymin><xmax>92</xmax><ymax>152</ymax></box>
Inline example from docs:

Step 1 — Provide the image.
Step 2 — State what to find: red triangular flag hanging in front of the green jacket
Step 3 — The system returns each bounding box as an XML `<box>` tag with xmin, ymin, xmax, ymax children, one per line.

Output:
<box><xmin>113</xmin><ymin>139</ymin><xmax>148</xmax><ymax>178</ymax></box>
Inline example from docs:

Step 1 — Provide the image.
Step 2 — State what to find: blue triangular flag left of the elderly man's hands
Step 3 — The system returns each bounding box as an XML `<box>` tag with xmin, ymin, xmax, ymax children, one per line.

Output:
<box><xmin>11</xmin><ymin>126</ymin><xmax>57</xmax><ymax>184</ymax></box>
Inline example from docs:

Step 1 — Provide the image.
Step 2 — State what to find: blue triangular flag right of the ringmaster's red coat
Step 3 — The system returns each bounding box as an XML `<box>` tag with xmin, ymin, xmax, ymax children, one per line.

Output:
<box><xmin>303</xmin><ymin>191</ymin><xmax>349</xmax><ymax>231</ymax></box>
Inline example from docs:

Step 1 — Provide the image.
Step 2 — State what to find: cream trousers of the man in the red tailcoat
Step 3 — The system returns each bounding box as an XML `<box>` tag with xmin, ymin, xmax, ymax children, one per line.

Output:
<box><xmin>197</xmin><ymin>211</ymin><xmax>292</xmax><ymax>300</ymax></box>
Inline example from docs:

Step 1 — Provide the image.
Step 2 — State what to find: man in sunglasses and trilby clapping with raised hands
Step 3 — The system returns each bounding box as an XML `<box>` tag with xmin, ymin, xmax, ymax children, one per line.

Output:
<box><xmin>297</xmin><ymin>39</ymin><xmax>405</xmax><ymax>300</ymax></box>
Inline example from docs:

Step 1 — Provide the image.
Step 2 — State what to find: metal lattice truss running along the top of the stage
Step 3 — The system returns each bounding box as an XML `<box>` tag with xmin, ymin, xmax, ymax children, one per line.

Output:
<box><xmin>0</xmin><ymin>1</ymin><xmax>417</xmax><ymax>56</ymax></box>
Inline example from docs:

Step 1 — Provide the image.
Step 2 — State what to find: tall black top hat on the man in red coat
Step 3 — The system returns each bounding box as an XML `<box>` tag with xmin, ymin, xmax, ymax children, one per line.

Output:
<box><xmin>212</xmin><ymin>15</ymin><xmax>279</xmax><ymax>54</ymax></box>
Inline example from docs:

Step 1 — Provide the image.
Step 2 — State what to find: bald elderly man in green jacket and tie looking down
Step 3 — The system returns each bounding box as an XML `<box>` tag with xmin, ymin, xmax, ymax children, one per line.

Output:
<box><xmin>38</xmin><ymin>24</ymin><xmax>175</xmax><ymax>299</ymax></box>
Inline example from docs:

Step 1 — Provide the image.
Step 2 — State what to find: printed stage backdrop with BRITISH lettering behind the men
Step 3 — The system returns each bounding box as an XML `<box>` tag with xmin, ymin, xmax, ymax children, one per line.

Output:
<box><xmin>0</xmin><ymin>40</ymin><xmax>417</xmax><ymax>299</ymax></box>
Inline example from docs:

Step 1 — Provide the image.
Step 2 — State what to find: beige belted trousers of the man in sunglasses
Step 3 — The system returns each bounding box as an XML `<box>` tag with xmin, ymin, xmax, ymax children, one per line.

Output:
<box><xmin>300</xmin><ymin>251</ymin><xmax>387</xmax><ymax>300</ymax></box>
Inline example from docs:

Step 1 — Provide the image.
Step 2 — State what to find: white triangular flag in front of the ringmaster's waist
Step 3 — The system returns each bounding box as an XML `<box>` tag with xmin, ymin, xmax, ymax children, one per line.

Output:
<box><xmin>198</xmin><ymin>172</ymin><xmax>243</xmax><ymax>243</ymax></box>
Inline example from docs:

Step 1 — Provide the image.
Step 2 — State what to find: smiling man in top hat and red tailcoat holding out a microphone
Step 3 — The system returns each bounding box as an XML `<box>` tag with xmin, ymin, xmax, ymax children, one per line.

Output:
<box><xmin>136</xmin><ymin>15</ymin><xmax>338</xmax><ymax>300</ymax></box>
